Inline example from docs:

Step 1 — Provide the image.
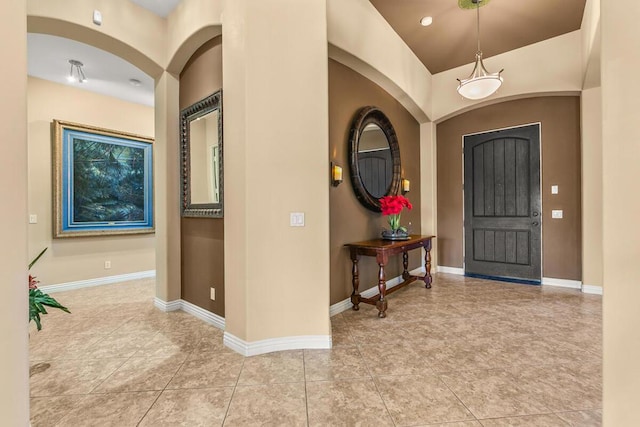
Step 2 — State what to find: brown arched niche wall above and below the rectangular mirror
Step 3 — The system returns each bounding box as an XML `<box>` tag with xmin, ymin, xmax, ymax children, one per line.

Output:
<box><xmin>176</xmin><ymin>37</ymin><xmax>224</xmax><ymax>317</ymax></box>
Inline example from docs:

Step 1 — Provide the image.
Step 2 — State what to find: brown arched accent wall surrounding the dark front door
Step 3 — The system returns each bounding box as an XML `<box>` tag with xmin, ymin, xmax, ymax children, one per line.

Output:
<box><xmin>436</xmin><ymin>96</ymin><xmax>582</xmax><ymax>280</ymax></box>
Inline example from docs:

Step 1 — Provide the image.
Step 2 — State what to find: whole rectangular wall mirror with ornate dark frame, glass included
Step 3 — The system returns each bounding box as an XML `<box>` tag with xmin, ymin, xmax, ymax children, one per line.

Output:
<box><xmin>180</xmin><ymin>90</ymin><xmax>224</xmax><ymax>218</ymax></box>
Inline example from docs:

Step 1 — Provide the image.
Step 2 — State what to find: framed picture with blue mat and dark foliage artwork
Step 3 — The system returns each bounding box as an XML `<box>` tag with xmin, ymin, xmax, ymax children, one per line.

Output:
<box><xmin>53</xmin><ymin>120</ymin><xmax>154</xmax><ymax>237</ymax></box>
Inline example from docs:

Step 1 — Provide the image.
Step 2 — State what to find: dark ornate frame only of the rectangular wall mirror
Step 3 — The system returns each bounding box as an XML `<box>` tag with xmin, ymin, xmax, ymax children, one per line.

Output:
<box><xmin>180</xmin><ymin>90</ymin><xmax>224</xmax><ymax>218</ymax></box>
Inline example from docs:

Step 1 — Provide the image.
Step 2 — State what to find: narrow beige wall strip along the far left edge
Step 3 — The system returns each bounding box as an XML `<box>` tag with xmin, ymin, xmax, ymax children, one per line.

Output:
<box><xmin>0</xmin><ymin>2</ymin><xmax>29</xmax><ymax>427</ymax></box>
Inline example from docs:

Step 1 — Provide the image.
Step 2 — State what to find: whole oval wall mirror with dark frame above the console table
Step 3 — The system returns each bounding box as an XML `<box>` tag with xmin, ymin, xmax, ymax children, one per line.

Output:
<box><xmin>349</xmin><ymin>106</ymin><xmax>401</xmax><ymax>212</ymax></box>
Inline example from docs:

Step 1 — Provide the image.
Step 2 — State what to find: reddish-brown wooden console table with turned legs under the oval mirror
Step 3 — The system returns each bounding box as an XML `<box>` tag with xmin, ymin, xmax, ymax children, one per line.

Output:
<box><xmin>345</xmin><ymin>235</ymin><xmax>436</xmax><ymax>317</ymax></box>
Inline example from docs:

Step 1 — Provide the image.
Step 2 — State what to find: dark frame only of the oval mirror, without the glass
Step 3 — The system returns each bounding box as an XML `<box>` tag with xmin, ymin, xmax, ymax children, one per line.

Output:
<box><xmin>349</xmin><ymin>106</ymin><xmax>401</xmax><ymax>212</ymax></box>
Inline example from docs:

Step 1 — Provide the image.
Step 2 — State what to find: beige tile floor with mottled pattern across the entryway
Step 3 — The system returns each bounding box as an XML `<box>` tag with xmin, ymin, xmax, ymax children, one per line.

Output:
<box><xmin>30</xmin><ymin>274</ymin><xmax>602</xmax><ymax>427</ymax></box>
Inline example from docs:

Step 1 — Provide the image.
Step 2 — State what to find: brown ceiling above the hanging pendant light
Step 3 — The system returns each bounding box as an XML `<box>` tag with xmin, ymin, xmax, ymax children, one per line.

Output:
<box><xmin>370</xmin><ymin>0</ymin><xmax>586</xmax><ymax>74</ymax></box>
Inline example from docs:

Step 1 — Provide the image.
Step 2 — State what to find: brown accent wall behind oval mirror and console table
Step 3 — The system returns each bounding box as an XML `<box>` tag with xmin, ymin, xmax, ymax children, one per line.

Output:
<box><xmin>327</xmin><ymin>60</ymin><xmax>422</xmax><ymax>304</ymax></box>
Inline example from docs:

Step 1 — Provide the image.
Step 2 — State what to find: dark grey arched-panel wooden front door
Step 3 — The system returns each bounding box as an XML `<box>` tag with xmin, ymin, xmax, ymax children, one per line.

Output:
<box><xmin>464</xmin><ymin>125</ymin><xmax>542</xmax><ymax>281</ymax></box>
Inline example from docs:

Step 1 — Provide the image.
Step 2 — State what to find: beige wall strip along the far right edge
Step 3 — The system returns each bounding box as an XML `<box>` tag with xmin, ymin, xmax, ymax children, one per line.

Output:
<box><xmin>601</xmin><ymin>0</ymin><xmax>640</xmax><ymax>427</ymax></box>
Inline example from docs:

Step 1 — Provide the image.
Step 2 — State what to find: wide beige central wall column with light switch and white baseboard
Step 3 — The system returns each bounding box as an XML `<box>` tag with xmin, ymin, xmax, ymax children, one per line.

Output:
<box><xmin>222</xmin><ymin>0</ymin><xmax>330</xmax><ymax>354</ymax></box>
